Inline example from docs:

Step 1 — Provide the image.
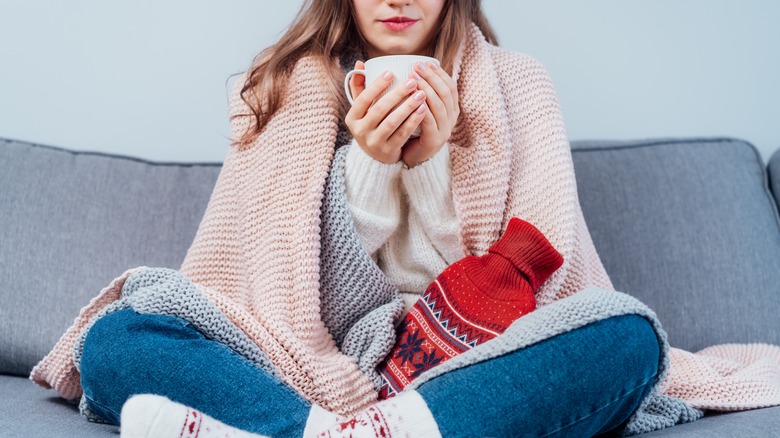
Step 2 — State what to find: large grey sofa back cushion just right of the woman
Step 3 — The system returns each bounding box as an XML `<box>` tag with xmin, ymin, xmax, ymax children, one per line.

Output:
<box><xmin>572</xmin><ymin>139</ymin><xmax>780</xmax><ymax>351</ymax></box>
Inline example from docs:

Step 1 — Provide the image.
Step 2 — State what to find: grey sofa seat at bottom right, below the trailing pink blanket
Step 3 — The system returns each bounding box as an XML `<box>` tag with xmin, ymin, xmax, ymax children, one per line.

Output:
<box><xmin>639</xmin><ymin>406</ymin><xmax>780</xmax><ymax>438</ymax></box>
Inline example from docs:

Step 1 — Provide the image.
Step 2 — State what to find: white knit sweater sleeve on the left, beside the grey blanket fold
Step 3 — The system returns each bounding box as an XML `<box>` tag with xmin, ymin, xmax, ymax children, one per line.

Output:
<box><xmin>345</xmin><ymin>140</ymin><xmax>402</xmax><ymax>257</ymax></box>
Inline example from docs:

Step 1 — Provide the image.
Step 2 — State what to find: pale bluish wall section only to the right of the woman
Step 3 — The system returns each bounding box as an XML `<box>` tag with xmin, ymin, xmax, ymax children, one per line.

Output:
<box><xmin>484</xmin><ymin>0</ymin><xmax>780</xmax><ymax>159</ymax></box>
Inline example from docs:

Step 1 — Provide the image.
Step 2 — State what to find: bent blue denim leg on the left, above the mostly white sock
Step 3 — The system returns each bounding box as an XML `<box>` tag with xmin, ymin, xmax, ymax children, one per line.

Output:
<box><xmin>81</xmin><ymin>310</ymin><xmax>311</xmax><ymax>437</ymax></box>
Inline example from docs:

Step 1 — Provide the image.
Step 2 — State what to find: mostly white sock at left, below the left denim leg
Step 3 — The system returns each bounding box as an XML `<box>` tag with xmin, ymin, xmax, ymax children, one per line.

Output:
<box><xmin>120</xmin><ymin>394</ymin><xmax>270</xmax><ymax>438</ymax></box>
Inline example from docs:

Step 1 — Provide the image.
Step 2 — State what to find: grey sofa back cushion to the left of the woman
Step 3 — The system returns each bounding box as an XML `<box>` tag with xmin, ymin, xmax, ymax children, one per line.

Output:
<box><xmin>0</xmin><ymin>139</ymin><xmax>220</xmax><ymax>375</ymax></box>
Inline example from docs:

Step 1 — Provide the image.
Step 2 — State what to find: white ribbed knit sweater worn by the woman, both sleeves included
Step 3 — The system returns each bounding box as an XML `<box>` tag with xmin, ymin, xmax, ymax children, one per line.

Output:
<box><xmin>345</xmin><ymin>140</ymin><xmax>465</xmax><ymax>310</ymax></box>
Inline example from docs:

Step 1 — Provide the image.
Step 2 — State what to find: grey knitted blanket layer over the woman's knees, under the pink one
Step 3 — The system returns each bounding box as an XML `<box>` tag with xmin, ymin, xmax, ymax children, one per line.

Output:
<box><xmin>73</xmin><ymin>146</ymin><xmax>703</xmax><ymax>435</ymax></box>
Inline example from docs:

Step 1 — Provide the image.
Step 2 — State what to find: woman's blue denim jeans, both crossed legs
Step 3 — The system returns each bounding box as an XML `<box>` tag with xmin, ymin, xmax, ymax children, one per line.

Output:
<box><xmin>81</xmin><ymin>309</ymin><xmax>659</xmax><ymax>437</ymax></box>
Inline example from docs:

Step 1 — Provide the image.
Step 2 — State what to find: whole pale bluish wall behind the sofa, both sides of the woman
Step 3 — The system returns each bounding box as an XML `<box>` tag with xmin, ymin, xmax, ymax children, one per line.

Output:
<box><xmin>0</xmin><ymin>0</ymin><xmax>780</xmax><ymax>161</ymax></box>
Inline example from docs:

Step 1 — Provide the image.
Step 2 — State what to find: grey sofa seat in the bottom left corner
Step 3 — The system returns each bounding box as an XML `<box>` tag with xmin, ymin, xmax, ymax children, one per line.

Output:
<box><xmin>0</xmin><ymin>375</ymin><xmax>119</xmax><ymax>438</ymax></box>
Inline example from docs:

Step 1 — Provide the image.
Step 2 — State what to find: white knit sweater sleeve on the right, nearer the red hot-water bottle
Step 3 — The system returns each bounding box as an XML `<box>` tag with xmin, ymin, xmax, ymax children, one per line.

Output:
<box><xmin>401</xmin><ymin>144</ymin><xmax>465</xmax><ymax>264</ymax></box>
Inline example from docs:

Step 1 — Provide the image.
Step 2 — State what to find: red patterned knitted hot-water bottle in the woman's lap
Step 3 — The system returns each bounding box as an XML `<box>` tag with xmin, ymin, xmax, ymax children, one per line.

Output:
<box><xmin>378</xmin><ymin>218</ymin><xmax>563</xmax><ymax>399</ymax></box>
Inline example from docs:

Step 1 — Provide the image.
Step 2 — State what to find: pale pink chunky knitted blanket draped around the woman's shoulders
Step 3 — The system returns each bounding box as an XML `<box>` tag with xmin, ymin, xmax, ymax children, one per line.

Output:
<box><xmin>31</xmin><ymin>27</ymin><xmax>780</xmax><ymax>414</ymax></box>
